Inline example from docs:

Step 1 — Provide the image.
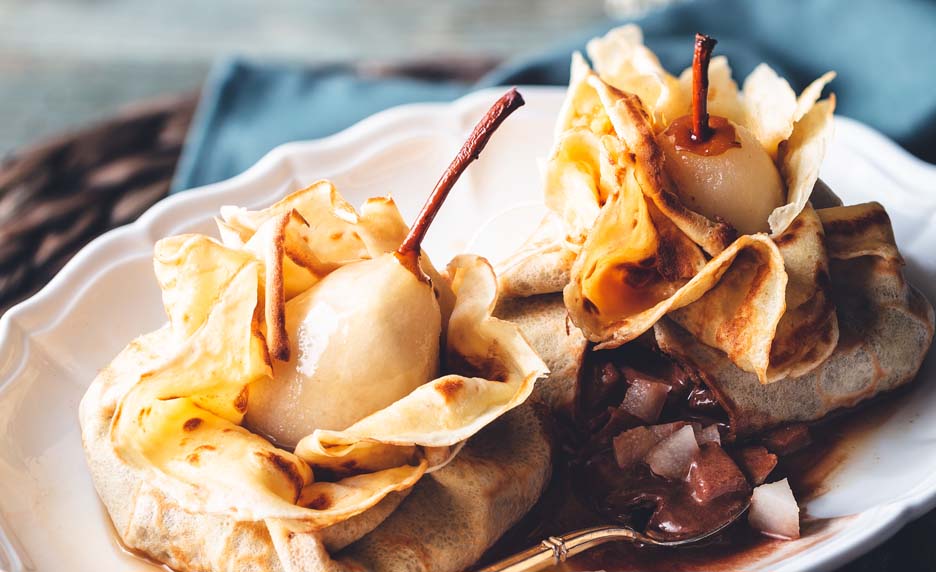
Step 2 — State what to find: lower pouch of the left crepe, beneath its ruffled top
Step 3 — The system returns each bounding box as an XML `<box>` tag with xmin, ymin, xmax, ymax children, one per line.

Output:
<box><xmin>82</xmin><ymin>388</ymin><xmax>551</xmax><ymax>572</ymax></box>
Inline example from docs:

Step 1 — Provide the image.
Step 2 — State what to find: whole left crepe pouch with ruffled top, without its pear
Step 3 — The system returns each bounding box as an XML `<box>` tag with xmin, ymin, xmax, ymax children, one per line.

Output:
<box><xmin>81</xmin><ymin>182</ymin><xmax>549</xmax><ymax>570</ymax></box>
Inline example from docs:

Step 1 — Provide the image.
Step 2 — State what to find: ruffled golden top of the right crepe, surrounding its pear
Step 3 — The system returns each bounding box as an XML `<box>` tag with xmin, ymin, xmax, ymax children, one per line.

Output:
<box><xmin>498</xmin><ymin>26</ymin><xmax>838</xmax><ymax>383</ymax></box>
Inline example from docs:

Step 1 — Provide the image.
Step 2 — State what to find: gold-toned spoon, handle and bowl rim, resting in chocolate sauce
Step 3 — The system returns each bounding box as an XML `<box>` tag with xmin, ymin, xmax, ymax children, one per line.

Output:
<box><xmin>477</xmin><ymin>502</ymin><xmax>751</xmax><ymax>572</ymax></box>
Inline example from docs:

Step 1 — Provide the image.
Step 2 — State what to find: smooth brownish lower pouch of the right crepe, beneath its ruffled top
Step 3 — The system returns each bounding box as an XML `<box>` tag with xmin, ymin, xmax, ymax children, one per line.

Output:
<box><xmin>654</xmin><ymin>203</ymin><xmax>934</xmax><ymax>436</ymax></box>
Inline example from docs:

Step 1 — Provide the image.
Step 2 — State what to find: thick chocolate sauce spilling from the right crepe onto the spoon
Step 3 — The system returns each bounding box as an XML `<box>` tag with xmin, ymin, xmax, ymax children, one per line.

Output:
<box><xmin>568</xmin><ymin>342</ymin><xmax>751</xmax><ymax>540</ymax></box>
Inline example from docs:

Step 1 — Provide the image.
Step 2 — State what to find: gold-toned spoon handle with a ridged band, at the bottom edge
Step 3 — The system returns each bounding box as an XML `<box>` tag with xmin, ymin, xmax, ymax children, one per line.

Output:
<box><xmin>477</xmin><ymin>526</ymin><xmax>638</xmax><ymax>572</ymax></box>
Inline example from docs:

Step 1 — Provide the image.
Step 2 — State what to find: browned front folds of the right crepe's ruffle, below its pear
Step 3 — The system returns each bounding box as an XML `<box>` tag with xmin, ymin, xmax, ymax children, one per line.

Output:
<box><xmin>564</xmin><ymin>76</ymin><xmax>837</xmax><ymax>383</ymax></box>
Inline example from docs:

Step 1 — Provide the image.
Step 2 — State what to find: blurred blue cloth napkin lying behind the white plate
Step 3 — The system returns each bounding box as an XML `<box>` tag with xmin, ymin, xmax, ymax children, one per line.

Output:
<box><xmin>173</xmin><ymin>0</ymin><xmax>936</xmax><ymax>192</ymax></box>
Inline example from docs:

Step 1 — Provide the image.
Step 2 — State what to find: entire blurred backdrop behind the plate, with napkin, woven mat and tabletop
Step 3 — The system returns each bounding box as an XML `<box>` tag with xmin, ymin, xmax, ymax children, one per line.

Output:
<box><xmin>0</xmin><ymin>0</ymin><xmax>936</xmax><ymax>306</ymax></box>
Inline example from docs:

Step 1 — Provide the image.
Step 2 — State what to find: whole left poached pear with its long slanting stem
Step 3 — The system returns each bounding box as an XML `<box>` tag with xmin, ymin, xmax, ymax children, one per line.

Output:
<box><xmin>246</xmin><ymin>89</ymin><xmax>524</xmax><ymax>447</ymax></box>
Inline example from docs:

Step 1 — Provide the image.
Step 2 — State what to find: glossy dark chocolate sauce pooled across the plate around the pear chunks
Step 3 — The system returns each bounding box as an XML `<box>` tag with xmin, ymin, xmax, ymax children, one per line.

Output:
<box><xmin>482</xmin><ymin>342</ymin><xmax>903</xmax><ymax>572</ymax></box>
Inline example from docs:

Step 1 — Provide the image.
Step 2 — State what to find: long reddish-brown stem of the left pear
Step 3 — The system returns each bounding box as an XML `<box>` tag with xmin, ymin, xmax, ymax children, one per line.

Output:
<box><xmin>396</xmin><ymin>88</ymin><xmax>524</xmax><ymax>277</ymax></box>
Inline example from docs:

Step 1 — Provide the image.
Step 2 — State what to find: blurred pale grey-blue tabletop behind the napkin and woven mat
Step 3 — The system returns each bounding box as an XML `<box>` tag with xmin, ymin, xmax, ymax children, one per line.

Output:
<box><xmin>0</xmin><ymin>0</ymin><xmax>665</xmax><ymax>156</ymax></box>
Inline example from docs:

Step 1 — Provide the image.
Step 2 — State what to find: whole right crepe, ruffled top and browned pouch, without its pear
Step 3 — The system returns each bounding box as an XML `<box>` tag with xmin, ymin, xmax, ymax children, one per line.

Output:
<box><xmin>498</xmin><ymin>26</ymin><xmax>933</xmax><ymax>435</ymax></box>
